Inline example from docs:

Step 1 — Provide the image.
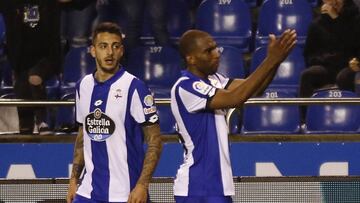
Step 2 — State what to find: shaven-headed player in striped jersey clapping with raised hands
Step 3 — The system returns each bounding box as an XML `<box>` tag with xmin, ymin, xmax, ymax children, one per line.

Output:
<box><xmin>171</xmin><ymin>30</ymin><xmax>296</xmax><ymax>203</ymax></box>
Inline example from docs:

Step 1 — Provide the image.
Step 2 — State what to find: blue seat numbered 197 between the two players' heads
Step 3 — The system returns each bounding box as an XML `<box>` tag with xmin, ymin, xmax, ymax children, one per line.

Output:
<box><xmin>126</xmin><ymin>46</ymin><xmax>181</xmax><ymax>98</ymax></box>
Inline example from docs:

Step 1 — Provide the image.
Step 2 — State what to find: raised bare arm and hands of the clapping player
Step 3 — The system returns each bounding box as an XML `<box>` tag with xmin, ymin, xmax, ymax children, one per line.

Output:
<box><xmin>209</xmin><ymin>30</ymin><xmax>296</xmax><ymax>109</ymax></box>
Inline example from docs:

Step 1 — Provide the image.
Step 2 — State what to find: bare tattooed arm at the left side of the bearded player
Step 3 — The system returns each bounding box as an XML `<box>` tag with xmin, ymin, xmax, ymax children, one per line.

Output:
<box><xmin>66</xmin><ymin>127</ymin><xmax>85</xmax><ymax>203</ymax></box>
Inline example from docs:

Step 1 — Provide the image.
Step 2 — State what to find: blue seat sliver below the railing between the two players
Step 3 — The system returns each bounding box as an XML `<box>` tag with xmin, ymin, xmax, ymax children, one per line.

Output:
<box><xmin>156</xmin><ymin>104</ymin><xmax>176</xmax><ymax>135</ymax></box>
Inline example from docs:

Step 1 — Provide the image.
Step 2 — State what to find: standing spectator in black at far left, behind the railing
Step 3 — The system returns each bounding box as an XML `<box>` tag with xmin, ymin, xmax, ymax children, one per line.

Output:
<box><xmin>0</xmin><ymin>0</ymin><xmax>93</xmax><ymax>134</ymax></box>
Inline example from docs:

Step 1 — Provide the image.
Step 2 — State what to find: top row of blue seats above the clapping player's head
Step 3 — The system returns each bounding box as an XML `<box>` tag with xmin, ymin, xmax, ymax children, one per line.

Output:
<box><xmin>95</xmin><ymin>0</ymin><xmax>317</xmax><ymax>52</ymax></box>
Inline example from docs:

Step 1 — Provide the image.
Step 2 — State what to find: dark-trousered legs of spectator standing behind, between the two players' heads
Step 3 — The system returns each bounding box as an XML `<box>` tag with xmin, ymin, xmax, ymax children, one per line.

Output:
<box><xmin>99</xmin><ymin>0</ymin><xmax>170</xmax><ymax>51</ymax></box>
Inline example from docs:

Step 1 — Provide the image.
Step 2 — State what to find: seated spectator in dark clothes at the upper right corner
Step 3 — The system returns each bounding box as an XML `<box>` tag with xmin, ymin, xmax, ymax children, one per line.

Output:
<box><xmin>299</xmin><ymin>0</ymin><xmax>360</xmax><ymax>97</ymax></box>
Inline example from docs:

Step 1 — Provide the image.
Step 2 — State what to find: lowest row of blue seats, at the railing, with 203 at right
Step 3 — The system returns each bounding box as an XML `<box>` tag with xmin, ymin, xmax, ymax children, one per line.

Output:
<box><xmin>40</xmin><ymin>89</ymin><xmax>360</xmax><ymax>135</ymax></box>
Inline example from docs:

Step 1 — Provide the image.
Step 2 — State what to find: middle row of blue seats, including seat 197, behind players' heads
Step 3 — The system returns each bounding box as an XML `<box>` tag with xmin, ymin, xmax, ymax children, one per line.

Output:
<box><xmin>0</xmin><ymin>43</ymin><xmax>305</xmax><ymax>99</ymax></box>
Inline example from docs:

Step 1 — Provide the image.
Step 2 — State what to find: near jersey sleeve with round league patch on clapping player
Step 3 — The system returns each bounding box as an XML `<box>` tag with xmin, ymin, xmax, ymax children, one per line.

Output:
<box><xmin>177</xmin><ymin>80</ymin><xmax>216</xmax><ymax>112</ymax></box>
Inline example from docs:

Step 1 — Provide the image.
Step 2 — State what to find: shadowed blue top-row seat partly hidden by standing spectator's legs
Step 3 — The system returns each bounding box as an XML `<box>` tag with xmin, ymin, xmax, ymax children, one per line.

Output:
<box><xmin>141</xmin><ymin>0</ymin><xmax>192</xmax><ymax>45</ymax></box>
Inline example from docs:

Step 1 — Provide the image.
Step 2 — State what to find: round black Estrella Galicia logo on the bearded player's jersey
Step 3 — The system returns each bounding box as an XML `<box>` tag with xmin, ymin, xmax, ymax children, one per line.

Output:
<box><xmin>85</xmin><ymin>108</ymin><xmax>115</xmax><ymax>142</ymax></box>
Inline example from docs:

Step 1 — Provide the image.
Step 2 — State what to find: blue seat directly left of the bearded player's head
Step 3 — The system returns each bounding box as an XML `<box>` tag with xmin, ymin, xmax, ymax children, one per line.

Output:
<box><xmin>61</xmin><ymin>46</ymin><xmax>96</xmax><ymax>95</ymax></box>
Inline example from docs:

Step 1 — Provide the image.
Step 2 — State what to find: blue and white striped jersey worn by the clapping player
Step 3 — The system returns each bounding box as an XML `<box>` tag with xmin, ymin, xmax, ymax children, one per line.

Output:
<box><xmin>171</xmin><ymin>71</ymin><xmax>235</xmax><ymax>196</ymax></box>
